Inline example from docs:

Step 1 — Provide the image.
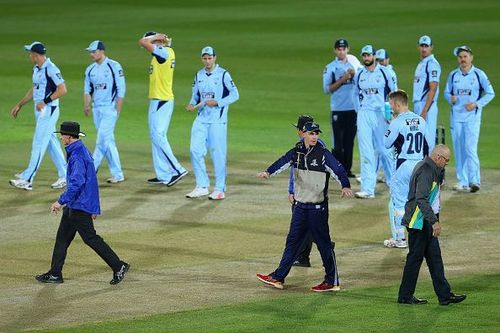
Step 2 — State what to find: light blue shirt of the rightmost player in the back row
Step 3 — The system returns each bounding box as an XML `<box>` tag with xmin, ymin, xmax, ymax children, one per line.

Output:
<box><xmin>444</xmin><ymin>66</ymin><xmax>495</xmax><ymax>122</ymax></box>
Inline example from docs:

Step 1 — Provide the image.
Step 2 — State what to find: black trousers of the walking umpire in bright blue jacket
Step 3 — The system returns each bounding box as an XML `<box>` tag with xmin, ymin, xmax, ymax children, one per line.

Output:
<box><xmin>50</xmin><ymin>207</ymin><xmax>122</xmax><ymax>274</ymax></box>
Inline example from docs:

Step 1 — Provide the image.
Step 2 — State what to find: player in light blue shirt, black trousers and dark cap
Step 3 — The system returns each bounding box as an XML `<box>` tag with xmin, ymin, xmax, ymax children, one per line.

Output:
<box><xmin>323</xmin><ymin>39</ymin><xmax>357</xmax><ymax>177</ymax></box>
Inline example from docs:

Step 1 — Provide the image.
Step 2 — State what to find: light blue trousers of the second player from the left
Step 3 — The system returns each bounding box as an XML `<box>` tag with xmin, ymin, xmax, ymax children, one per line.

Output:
<box><xmin>93</xmin><ymin>105</ymin><xmax>124</xmax><ymax>179</ymax></box>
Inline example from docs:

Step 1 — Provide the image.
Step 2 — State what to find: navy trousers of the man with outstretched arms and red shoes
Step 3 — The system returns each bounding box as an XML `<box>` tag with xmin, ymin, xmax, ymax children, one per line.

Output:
<box><xmin>272</xmin><ymin>203</ymin><xmax>340</xmax><ymax>286</ymax></box>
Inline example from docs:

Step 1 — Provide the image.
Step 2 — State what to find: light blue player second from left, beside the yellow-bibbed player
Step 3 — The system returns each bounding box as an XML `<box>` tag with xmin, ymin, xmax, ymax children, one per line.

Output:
<box><xmin>83</xmin><ymin>40</ymin><xmax>126</xmax><ymax>184</ymax></box>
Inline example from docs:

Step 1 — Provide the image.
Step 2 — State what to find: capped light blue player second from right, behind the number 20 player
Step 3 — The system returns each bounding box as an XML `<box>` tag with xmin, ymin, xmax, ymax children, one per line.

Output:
<box><xmin>413</xmin><ymin>36</ymin><xmax>441</xmax><ymax>151</ymax></box>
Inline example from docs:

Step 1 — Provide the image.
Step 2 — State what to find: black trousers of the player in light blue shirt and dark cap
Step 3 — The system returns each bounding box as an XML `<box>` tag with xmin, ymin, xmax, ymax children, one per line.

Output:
<box><xmin>332</xmin><ymin>110</ymin><xmax>357</xmax><ymax>174</ymax></box>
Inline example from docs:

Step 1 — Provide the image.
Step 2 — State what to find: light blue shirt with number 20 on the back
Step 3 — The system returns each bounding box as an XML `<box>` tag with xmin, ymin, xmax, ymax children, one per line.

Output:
<box><xmin>384</xmin><ymin>111</ymin><xmax>429</xmax><ymax>161</ymax></box>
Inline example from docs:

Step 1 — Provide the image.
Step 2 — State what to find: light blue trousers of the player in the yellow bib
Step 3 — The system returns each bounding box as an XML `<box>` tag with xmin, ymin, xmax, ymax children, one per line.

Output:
<box><xmin>148</xmin><ymin>99</ymin><xmax>186</xmax><ymax>181</ymax></box>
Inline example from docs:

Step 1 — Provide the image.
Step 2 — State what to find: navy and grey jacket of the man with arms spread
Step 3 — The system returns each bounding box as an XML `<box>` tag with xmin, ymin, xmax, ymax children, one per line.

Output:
<box><xmin>267</xmin><ymin>141</ymin><xmax>351</xmax><ymax>204</ymax></box>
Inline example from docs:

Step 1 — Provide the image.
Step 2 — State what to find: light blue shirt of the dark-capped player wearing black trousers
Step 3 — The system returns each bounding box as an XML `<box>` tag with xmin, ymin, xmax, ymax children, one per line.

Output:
<box><xmin>323</xmin><ymin>58</ymin><xmax>356</xmax><ymax>111</ymax></box>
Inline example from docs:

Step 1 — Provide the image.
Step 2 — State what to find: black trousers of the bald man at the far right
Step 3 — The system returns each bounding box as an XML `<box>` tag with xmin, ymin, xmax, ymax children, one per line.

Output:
<box><xmin>399</xmin><ymin>221</ymin><xmax>451</xmax><ymax>301</ymax></box>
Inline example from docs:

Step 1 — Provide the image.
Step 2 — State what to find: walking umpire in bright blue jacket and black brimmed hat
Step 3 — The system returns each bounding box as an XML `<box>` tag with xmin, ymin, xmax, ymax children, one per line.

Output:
<box><xmin>35</xmin><ymin>121</ymin><xmax>130</xmax><ymax>284</ymax></box>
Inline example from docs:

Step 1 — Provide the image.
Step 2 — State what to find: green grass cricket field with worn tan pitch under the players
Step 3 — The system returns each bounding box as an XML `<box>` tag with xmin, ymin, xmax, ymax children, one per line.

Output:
<box><xmin>0</xmin><ymin>0</ymin><xmax>500</xmax><ymax>332</ymax></box>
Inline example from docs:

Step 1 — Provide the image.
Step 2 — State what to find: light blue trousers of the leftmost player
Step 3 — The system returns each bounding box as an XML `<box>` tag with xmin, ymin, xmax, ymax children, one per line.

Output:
<box><xmin>21</xmin><ymin>106</ymin><xmax>66</xmax><ymax>182</ymax></box>
